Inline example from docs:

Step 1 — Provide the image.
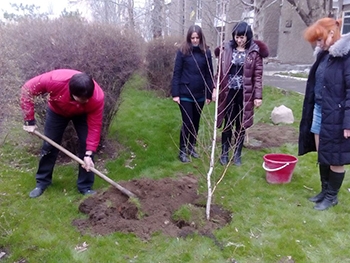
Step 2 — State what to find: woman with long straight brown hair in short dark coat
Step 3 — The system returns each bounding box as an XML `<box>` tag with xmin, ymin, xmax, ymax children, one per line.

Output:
<box><xmin>171</xmin><ymin>25</ymin><xmax>213</xmax><ymax>163</ymax></box>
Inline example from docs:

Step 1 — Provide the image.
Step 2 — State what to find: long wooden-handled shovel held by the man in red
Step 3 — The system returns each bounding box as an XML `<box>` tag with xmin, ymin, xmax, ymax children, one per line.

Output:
<box><xmin>33</xmin><ymin>130</ymin><xmax>137</xmax><ymax>198</ymax></box>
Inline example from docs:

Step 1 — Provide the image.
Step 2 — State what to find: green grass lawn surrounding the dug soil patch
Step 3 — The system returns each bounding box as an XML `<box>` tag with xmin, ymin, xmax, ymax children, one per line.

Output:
<box><xmin>0</xmin><ymin>77</ymin><xmax>350</xmax><ymax>263</ymax></box>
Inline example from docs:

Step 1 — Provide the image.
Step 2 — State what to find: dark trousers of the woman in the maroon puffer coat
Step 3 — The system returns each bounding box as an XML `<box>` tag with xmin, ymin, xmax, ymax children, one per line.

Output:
<box><xmin>222</xmin><ymin>89</ymin><xmax>245</xmax><ymax>145</ymax></box>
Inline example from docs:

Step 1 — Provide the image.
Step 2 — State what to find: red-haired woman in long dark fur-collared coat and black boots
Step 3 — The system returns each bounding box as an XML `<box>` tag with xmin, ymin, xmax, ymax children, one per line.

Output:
<box><xmin>299</xmin><ymin>18</ymin><xmax>350</xmax><ymax>210</ymax></box>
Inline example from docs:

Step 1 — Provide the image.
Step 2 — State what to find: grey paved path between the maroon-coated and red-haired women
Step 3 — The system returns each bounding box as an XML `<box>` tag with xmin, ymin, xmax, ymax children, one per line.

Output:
<box><xmin>263</xmin><ymin>63</ymin><xmax>310</xmax><ymax>94</ymax></box>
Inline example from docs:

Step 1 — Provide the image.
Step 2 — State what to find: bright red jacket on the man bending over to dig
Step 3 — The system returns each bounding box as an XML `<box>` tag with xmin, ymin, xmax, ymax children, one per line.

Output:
<box><xmin>21</xmin><ymin>69</ymin><xmax>104</xmax><ymax>151</ymax></box>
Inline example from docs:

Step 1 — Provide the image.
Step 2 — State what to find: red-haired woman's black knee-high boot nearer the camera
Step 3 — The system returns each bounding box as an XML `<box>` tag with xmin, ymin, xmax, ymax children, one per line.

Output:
<box><xmin>314</xmin><ymin>170</ymin><xmax>345</xmax><ymax>211</ymax></box>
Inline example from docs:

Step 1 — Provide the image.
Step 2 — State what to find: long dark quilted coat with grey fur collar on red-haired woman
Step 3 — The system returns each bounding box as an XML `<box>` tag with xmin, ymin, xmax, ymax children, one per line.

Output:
<box><xmin>299</xmin><ymin>34</ymin><xmax>350</xmax><ymax>166</ymax></box>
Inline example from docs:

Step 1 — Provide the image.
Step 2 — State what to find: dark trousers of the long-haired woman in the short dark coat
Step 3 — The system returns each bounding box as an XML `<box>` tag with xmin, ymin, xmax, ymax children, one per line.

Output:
<box><xmin>179</xmin><ymin>100</ymin><xmax>204</xmax><ymax>149</ymax></box>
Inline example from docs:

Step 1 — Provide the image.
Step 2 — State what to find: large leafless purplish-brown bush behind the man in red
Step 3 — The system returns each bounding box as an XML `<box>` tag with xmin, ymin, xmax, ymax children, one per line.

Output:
<box><xmin>0</xmin><ymin>17</ymin><xmax>143</xmax><ymax>151</ymax></box>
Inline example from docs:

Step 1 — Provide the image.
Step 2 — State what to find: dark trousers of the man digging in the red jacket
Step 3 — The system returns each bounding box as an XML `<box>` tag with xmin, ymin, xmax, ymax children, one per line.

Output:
<box><xmin>36</xmin><ymin>109</ymin><xmax>95</xmax><ymax>192</ymax></box>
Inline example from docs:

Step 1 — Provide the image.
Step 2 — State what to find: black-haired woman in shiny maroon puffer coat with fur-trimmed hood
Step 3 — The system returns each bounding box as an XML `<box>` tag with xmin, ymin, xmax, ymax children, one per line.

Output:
<box><xmin>213</xmin><ymin>22</ymin><xmax>269</xmax><ymax>165</ymax></box>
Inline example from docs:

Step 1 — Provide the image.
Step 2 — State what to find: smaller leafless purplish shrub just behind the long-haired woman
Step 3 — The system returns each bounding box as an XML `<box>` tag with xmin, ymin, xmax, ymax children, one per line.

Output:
<box><xmin>146</xmin><ymin>37</ymin><xmax>182</xmax><ymax>96</ymax></box>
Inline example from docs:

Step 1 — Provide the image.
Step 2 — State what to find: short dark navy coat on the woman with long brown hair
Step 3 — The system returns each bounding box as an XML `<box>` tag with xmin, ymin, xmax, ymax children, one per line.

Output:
<box><xmin>171</xmin><ymin>47</ymin><xmax>213</xmax><ymax>100</ymax></box>
